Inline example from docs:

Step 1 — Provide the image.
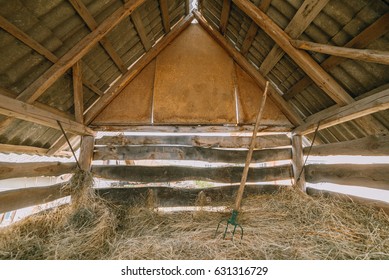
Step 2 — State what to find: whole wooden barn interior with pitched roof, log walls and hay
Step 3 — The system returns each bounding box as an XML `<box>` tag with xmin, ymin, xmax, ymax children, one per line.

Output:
<box><xmin>0</xmin><ymin>0</ymin><xmax>389</xmax><ymax>259</ymax></box>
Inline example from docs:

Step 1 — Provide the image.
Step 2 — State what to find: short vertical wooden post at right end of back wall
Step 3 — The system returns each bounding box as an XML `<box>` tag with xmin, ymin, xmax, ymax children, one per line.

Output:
<box><xmin>292</xmin><ymin>135</ymin><xmax>305</xmax><ymax>192</ymax></box>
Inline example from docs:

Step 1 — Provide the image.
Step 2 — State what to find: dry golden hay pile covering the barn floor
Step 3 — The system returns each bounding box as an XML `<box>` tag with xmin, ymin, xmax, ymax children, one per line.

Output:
<box><xmin>0</xmin><ymin>174</ymin><xmax>389</xmax><ymax>259</ymax></box>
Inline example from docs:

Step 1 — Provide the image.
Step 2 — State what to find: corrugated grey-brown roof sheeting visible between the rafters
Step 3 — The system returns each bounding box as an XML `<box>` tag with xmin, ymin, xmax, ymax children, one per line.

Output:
<box><xmin>0</xmin><ymin>0</ymin><xmax>389</xmax><ymax>155</ymax></box>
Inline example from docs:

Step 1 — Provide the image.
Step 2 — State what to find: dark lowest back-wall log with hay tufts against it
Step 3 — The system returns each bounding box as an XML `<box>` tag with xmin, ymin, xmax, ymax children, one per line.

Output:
<box><xmin>96</xmin><ymin>185</ymin><xmax>283</xmax><ymax>207</ymax></box>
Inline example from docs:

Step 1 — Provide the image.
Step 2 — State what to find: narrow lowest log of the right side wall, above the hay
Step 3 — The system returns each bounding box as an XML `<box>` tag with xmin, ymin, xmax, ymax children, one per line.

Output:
<box><xmin>307</xmin><ymin>187</ymin><xmax>389</xmax><ymax>214</ymax></box>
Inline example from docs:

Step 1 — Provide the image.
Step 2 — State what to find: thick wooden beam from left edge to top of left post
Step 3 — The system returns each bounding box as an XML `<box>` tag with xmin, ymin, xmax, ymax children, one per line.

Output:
<box><xmin>0</xmin><ymin>95</ymin><xmax>95</xmax><ymax>135</ymax></box>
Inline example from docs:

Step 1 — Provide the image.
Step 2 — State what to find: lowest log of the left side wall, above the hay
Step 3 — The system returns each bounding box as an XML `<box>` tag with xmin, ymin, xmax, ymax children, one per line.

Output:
<box><xmin>0</xmin><ymin>184</ymin><xmax>69</xmax><ymax>213</ymax></box>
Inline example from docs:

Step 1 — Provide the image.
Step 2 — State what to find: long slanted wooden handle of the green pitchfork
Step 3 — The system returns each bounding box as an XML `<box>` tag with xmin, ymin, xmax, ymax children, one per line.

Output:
<box><xmin>234</xmin><ymin>82</ymin><xmax>269</xmax><ymax>211</ymax></box>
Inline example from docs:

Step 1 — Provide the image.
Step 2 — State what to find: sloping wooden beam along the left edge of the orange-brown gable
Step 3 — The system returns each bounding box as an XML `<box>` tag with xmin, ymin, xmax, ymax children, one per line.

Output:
<box><xmin>85</xmin><ymin>15</ymin><xmax>193</xmax><ymax>124</ymax></box>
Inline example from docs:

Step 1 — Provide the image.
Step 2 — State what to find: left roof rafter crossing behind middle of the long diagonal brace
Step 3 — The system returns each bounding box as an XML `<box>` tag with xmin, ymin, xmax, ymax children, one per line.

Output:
<box><xmin>69</xmin><ymin>0</ymin><xmax>127</xmax><ymax>73</ymax></box>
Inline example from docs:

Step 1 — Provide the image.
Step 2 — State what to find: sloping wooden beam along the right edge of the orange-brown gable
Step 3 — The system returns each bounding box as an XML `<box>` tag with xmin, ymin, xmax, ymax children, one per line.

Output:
<box><xmin>194</xmin><ymin>11</ymin><xmax>304</xmax><ymax>126</ymax></box>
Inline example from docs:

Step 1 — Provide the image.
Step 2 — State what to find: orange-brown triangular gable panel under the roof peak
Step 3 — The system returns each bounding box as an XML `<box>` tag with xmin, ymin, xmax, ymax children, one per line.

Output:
<box><xmin>93</xmin><ymin>24</ymin><xmax>291</xmax><ymax>127</ymax></box>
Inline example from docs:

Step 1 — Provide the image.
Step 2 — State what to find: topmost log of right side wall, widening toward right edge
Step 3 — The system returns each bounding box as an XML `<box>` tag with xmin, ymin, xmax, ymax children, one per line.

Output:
<box><xmin>304</xmin><ymin>135</ymin><xmax>389</xmax><ymax>156</ymax></box>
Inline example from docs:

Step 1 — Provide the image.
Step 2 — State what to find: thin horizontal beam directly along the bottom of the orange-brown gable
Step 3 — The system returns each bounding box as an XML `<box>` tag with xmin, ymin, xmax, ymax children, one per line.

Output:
<box><xmin>89</xmin><ymin>124</ymin><xmax>293</xmax><ymax>134</ymax></box>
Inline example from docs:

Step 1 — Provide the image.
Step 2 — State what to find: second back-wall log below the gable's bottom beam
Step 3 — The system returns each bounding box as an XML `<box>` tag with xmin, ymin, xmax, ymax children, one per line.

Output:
<box><xmin>93</xmin><ymin>146</ymin><xmax>292</xmax><ymax>163</ymax></box>
